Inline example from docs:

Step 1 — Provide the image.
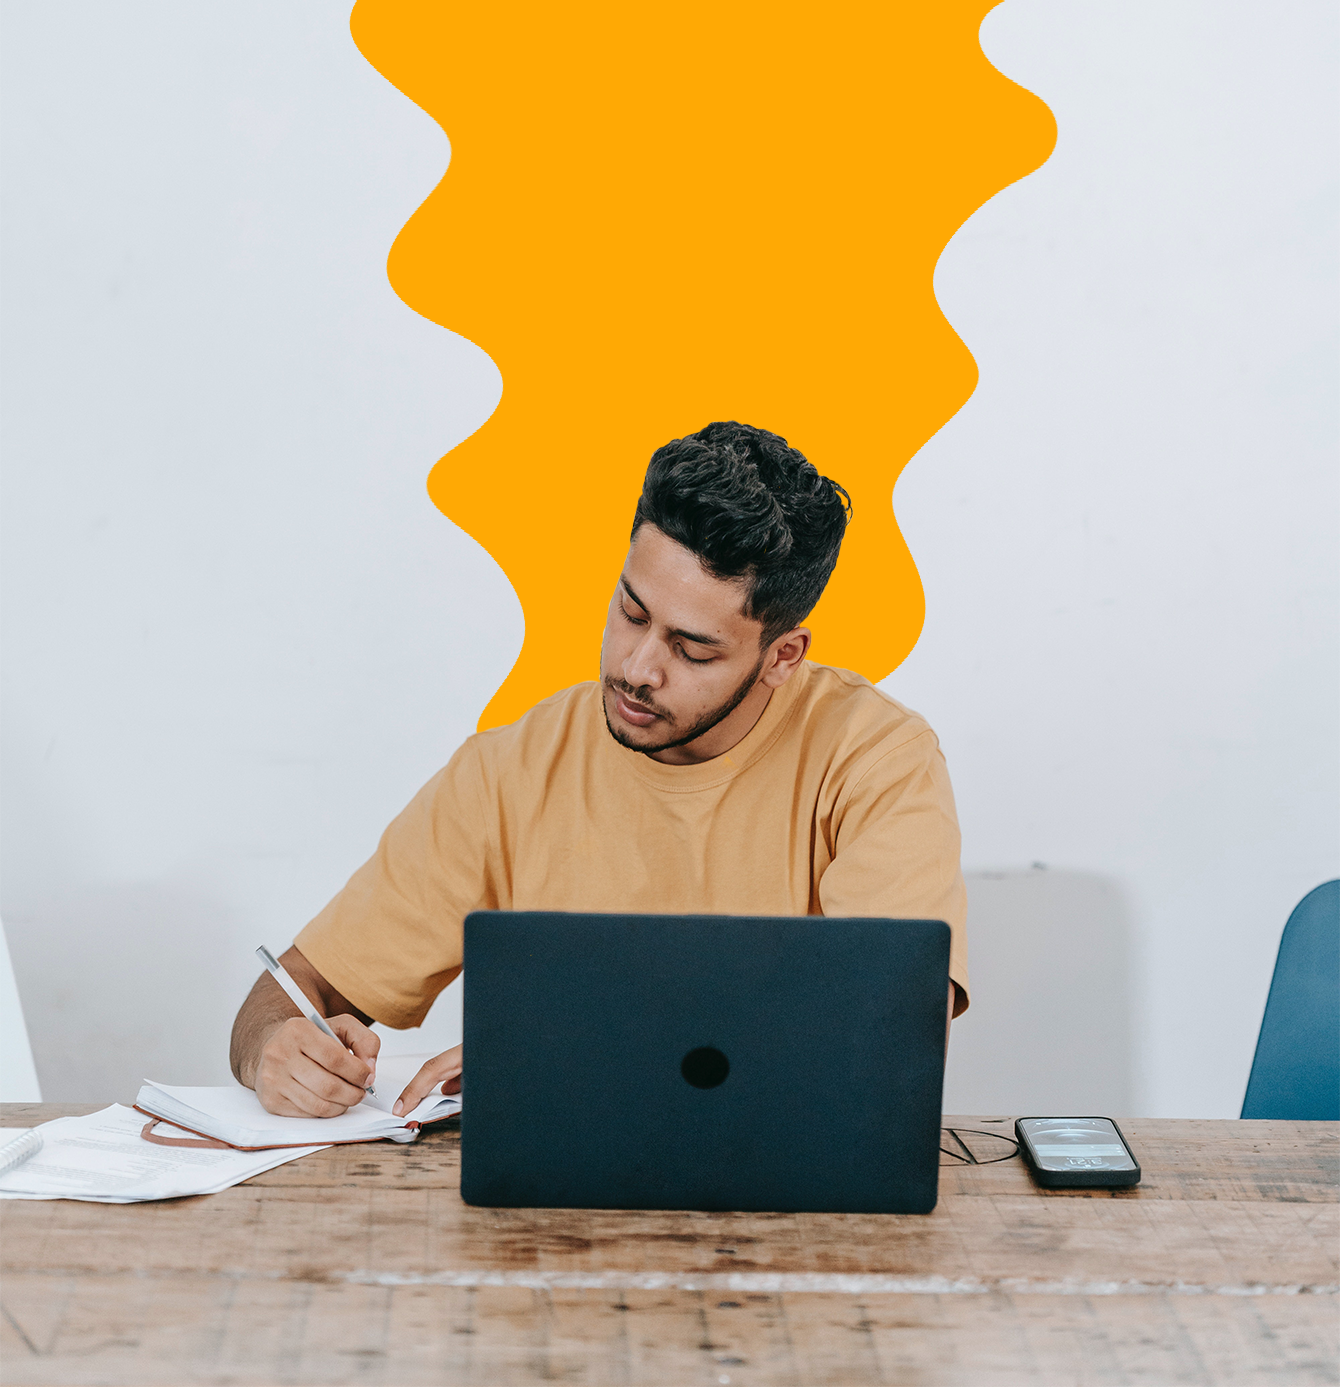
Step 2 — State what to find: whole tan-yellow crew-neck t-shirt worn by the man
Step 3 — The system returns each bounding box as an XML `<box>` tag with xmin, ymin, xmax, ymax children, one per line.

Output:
<box><xmin>295</xmin><ymin>663</ymin><xmax>968</xmax><ymax>1026</ymax></box>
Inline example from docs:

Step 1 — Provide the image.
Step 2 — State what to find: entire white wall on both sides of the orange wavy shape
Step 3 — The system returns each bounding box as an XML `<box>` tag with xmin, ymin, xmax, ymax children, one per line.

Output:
<box><xmin>0</xmin><ymin>0</ymin><xmax>1337</xmax><ymax>1115</ymax></box>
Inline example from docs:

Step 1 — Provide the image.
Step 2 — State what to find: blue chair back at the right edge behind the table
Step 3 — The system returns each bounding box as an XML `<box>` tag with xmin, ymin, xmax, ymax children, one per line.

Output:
<box><xmin>1243</xmin><ymin>881</ymin><xmax>1340</xmax><ymax>1121</ymax></box>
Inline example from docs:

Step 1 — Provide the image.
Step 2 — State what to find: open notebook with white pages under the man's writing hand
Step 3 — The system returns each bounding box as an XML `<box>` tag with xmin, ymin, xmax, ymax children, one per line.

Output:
<box><xmin>135</xmin><ymin>1054</ymin><xmax>461</xmax><ymax>1151</ymax></box>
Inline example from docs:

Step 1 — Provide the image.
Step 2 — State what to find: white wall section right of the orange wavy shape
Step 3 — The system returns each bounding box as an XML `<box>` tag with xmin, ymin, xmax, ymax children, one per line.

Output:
<box><xmin>909</xmin><ymin>0</ymin><xmax>1340</xmax><ymax>1117</ymax></box>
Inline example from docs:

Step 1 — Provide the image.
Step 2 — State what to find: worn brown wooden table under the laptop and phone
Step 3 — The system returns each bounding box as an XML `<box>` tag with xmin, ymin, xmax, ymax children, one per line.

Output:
<box><xmin>0</xmin><ymin>1104</ymin><xmax>1340</xmax><ymax>1387</ymax></box>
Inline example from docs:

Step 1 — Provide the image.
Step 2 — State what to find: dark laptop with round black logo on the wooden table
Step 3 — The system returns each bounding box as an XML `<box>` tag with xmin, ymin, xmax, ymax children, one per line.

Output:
<box><xmin>461</xmin><ymin>911</ymin><xmax>949</xmax><ymax>1214</ymax></box>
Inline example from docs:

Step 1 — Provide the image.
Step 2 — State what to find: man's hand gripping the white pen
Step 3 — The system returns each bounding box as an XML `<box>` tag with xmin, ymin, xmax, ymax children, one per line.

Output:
<box><xmin>252</xmin><ymin>1015</ymin><xmax>381</xmax><ymax>1118</ymax></box>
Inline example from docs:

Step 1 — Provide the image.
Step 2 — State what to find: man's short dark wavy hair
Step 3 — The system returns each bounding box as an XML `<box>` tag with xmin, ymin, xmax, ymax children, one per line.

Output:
<box><xmin>633</xmin><ymin>422</ymin><xmax>852</xmax><ymax>646</ymax></box>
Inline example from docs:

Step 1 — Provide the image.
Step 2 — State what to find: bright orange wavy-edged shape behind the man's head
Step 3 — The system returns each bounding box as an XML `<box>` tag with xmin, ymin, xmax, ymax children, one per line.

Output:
<box><xmin>351</xmin><ymin>0</ymin><xmax>1056</xmax><ymax>728</ymax></box>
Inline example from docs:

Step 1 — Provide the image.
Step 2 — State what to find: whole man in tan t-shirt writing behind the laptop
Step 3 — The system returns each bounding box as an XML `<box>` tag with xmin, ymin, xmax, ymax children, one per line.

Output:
<box><xmin>232</xmin><ymin>423</ymin><xmax>967</xmax><ymax>1117</ymax></box>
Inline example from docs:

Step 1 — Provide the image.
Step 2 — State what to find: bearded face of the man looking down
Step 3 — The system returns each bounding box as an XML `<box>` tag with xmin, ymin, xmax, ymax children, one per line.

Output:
<box><xmin>601</xmin><ymin>524</ymin><xmax>771</xmax><ymax>761</ymax></box>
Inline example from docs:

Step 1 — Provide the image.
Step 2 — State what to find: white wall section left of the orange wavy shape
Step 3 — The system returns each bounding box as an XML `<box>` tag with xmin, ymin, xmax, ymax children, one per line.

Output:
<box><xmin>3</xmin><ymin>0</ymin><xmax>507</xmax><ymax>1100</ymax></box>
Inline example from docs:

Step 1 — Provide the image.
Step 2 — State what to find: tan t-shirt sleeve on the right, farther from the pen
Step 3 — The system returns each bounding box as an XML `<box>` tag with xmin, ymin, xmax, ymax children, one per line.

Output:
<box><xmin>818</xmin><ymin>728</ymin><xmax>968</xmax><ymax>1015</ymax></box>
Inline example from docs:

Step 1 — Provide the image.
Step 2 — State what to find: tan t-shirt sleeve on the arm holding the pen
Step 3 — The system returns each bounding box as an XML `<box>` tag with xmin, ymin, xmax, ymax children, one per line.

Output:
<box><xmin>294</xmin><ymin>738</ymin><xmax>497</xmax><ymax>1028</ymax></box>
